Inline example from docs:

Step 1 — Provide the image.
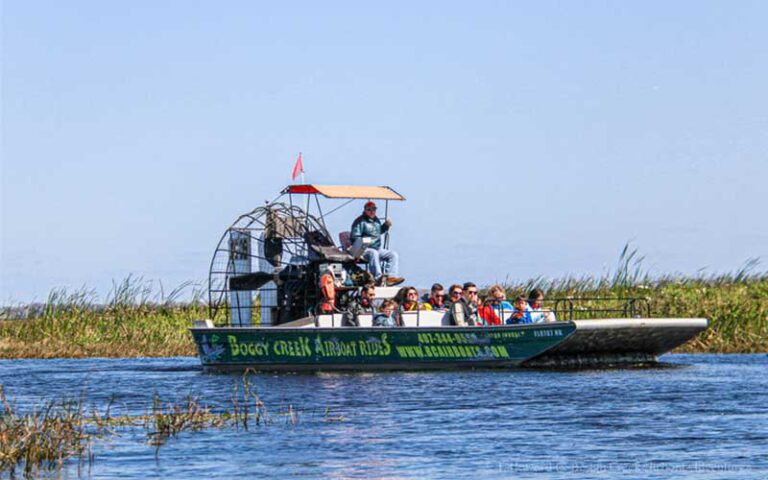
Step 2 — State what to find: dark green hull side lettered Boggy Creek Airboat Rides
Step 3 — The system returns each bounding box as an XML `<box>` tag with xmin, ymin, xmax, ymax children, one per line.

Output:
<box><xmin>191</xmin><ymin>322</ymin><xmax>576</xmax><ymax>371</ymax></box>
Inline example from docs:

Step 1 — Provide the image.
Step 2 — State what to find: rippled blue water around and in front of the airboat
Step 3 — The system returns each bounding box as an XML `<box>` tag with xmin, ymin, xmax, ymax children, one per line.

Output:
<box><xmin>0</xmin><ymin>354</ymin><xmax>768</xmax><ymax>479</ymax></box>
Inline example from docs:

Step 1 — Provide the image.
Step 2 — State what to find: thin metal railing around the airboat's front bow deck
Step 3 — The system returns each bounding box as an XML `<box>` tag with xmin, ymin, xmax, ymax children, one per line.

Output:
<box><xmin>547</xmin><ymin>297</ymin><xmax>651</xmax><ymax>320</ymax></box>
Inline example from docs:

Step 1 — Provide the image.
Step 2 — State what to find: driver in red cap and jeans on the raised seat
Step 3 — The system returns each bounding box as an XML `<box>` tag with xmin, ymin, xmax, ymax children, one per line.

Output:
<box><xmin>350</xmin><ymin>202</ymin><xmax>405</xmax><ymax>286</ymax></box>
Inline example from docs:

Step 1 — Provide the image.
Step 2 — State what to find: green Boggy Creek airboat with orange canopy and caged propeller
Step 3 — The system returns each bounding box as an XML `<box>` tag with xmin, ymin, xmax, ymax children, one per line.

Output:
<box><xmin>190</xmin><ymin>184</ymin><xmax>708</xmax><ymax>371</ymax></box>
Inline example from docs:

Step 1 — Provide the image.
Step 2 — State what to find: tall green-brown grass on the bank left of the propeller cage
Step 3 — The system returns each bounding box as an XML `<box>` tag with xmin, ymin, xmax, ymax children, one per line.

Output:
<box><xmin>0</xmin><ymin>277</ymin><xmax>208</xmax><ymax>358</ymax></box>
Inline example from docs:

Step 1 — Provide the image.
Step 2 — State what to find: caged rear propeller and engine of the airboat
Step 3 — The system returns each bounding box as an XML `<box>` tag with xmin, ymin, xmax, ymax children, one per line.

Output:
<box><xmin>208</xmin><ymin>203</ymin><xmax>372</xmax><ymax>326</ymax></box>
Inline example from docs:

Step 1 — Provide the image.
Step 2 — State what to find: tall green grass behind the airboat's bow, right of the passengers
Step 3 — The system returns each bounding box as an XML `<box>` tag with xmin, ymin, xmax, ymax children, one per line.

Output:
<box><xmin>505</xmin><ymin>244</ymin><xmax>768</xmax><ymax>352</ymax></box>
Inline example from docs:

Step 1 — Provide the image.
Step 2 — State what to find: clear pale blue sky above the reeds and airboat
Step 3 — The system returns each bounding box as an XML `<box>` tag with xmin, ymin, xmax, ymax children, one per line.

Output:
<box><xmin>0</xmin><ymin>0</ymin><xmax>768</xmax><ymax>304</ymax></box>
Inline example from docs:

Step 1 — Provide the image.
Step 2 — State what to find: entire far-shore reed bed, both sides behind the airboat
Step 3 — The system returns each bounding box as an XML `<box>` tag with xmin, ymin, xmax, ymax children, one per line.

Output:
<box><xmin>0</xmin><ymin>245</ymin><xmax>768</xmax><ymax>358</ymax></box>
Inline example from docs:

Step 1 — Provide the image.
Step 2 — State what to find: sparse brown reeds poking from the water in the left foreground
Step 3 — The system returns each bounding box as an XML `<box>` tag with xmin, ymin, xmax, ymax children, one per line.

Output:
<box><xmin>0</xmin><ymin>372</ymin><xmax>330</xmax><ymax>477</ymax></box>
